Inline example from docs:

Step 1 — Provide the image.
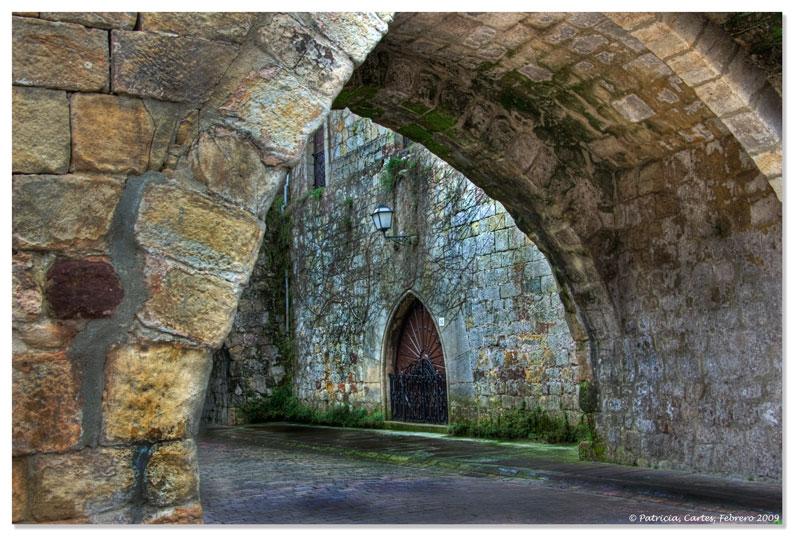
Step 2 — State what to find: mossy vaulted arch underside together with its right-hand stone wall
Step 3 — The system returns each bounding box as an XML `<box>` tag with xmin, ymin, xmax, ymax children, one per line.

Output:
<box><xmin>335</xmin><ymin>13</ymin><xmax>781</xmax><ymax>480</ymax></box>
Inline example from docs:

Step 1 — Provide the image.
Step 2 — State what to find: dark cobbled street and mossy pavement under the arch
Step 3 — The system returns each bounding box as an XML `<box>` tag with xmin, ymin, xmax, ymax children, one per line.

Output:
<box><xmin>198</xmin><ymin>425</ymin><xmax>780</xmax><ymax>524</ymax></box>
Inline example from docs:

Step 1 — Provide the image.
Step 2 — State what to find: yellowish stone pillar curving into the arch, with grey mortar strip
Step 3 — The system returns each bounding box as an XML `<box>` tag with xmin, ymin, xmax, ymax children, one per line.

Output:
<box><xmin>13</xmin><ymin>13</ymin><xmax>388</xmax><ymax>523</ymax></box>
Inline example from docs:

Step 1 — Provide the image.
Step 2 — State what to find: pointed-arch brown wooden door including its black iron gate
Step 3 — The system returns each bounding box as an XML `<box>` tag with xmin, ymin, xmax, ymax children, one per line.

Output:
<box><xmin>389</xmin><ymin>300</ymin><xmax>447</xmax><ymax>424</ymax></box>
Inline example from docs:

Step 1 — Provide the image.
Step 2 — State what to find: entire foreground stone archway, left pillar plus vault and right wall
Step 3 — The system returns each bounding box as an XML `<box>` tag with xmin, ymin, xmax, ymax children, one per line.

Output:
<box><xmin>12</xmin><ymin>13</ymin><xmax>782</xmax><ymax>522</ymax></box>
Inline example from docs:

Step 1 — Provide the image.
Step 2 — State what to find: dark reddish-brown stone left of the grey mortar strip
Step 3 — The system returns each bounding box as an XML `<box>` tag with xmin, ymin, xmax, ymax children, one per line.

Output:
<box><xmin>46</xmin><ymin>259</ymin><xmax>124</xmax><ymax>318</ymax></box>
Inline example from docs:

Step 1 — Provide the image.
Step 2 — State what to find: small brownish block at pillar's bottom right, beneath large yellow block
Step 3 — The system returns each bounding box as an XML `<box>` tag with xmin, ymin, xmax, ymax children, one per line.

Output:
<box><xmin>145</xmin><ymin>439</ymin><xmax>199</xmax><ymax>506</ymax></box>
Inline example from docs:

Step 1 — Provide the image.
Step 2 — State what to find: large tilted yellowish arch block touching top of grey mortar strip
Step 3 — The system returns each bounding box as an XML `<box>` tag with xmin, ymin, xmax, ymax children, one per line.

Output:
<box><xmin>135</xmin><ymin>185</ymin><xmax>262</xmax><ymax>278</ymax></box>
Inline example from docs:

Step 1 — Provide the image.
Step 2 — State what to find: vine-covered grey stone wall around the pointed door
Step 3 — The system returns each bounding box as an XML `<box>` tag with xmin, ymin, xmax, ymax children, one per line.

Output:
<box><xmin>288</xmin><ymin>111</ymin><xmax>587</xmax><ymax>423</ymax></box>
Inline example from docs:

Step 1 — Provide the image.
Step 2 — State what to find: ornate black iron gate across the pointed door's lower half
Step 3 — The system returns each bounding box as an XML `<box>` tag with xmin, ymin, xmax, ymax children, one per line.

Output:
<box><xmin>389</xmin><ymin>357</ymin><xmax>447</xmax><ymax>424</ymax></box>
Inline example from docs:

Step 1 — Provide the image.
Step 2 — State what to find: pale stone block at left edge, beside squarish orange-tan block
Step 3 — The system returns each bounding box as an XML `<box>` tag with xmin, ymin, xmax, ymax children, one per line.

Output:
<box><xmin>11</xmin><ymin>87</ymin><xmax>70</xmax><ymax>173</ymax></box>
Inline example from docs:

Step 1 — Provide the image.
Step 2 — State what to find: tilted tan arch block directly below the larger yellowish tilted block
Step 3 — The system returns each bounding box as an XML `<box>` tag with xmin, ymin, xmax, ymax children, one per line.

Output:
<box><xmin>138</xmin><ymin>260</ymin><xmax>237</xmax><ymax>346</ymax></box>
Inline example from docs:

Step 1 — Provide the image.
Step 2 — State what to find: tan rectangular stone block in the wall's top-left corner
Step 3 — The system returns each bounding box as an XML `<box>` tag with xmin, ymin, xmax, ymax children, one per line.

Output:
<box><xmin>11</xmin><ymin>17</ymin><xmax>109</xmax><ymax>91</ymax></box>
